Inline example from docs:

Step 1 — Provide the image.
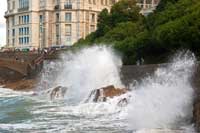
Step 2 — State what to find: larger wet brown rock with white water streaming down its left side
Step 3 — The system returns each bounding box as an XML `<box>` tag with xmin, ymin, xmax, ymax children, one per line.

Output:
<box><xmin>86</xmin><ymin>85</ymin><xmax>128</xmax><ymax>102</ymax></box>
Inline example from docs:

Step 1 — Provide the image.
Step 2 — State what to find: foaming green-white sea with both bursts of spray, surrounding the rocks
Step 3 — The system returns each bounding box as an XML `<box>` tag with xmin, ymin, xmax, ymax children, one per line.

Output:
<box><xmin>0</xmin><ymin>46</ymin><xmax>196</xmax><ymax>133</ymax></box>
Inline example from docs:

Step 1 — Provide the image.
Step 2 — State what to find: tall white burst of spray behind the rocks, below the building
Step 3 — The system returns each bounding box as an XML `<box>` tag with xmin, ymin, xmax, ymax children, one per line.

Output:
<box><xmin>48</xmin><ymin>46</ymin><xmax>123</xmax><ymax>102</ymax></box>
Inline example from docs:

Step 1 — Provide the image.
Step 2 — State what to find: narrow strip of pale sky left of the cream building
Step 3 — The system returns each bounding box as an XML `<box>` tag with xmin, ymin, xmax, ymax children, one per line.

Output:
<box><xmin>0</xmin><ymin>0</ymin><xmax>7</xmax><ymax>46</ymax></box>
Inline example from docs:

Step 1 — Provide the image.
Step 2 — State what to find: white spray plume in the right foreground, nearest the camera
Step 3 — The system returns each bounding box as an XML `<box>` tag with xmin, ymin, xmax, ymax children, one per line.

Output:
<box><xmin>128</xmin><ymin>52</ymin><xmax>196</xmax><ymax>129</ymax></box>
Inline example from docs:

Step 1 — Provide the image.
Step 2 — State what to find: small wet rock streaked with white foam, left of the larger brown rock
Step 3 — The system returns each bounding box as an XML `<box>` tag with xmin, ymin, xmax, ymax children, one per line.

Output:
<box><xmin>47</xmin><ymin>86</ymin><xmax>68</xmax><ymax>100</ymax></box>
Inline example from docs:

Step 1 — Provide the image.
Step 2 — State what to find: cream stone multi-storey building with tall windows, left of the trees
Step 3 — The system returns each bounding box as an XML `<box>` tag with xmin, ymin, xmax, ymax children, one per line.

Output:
<box><xmin>5</xmin><ymin>0</ymin><xmax>160</xmax><ymax>49</ymax></box>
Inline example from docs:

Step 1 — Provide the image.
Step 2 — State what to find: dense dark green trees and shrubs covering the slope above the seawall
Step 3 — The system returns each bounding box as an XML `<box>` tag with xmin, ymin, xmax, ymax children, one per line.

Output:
<box><xmin>76</xmin><ymin>0</ymin><xmax>200</xmax><ymax>64</ymax></box>
